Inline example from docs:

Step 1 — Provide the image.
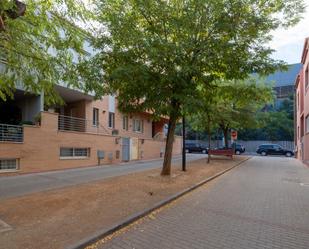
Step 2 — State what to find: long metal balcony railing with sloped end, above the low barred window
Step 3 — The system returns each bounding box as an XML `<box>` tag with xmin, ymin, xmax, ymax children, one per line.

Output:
<box><xmin>58</xmin><ymin>115</ymin><xmax>110</xmax><ymax>134</ymax></box>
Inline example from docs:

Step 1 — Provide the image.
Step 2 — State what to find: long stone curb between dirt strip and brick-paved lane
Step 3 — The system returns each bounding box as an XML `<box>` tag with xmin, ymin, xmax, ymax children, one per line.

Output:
<box><xmin>67</xmin><ymin>157</ymin><xmax>251</xmax><ymax>249</ymax></box>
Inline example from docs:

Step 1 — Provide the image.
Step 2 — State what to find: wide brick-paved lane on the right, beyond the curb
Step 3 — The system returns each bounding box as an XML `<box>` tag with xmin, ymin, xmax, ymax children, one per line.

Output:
<box><xmin>91</xmin><ymin>157</ymin><xmax>309</xmax><ymax>249</ymax></box>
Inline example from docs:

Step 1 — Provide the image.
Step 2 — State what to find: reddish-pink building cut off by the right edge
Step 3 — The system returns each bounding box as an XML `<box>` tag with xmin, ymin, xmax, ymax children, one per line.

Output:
<box><xmin>295</xmin><ymin>38</ymin><xmax>309</xmax><ymax>164</ymax></box>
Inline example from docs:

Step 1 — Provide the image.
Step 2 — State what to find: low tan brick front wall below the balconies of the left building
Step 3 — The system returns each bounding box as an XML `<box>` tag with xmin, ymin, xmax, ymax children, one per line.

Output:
<box><xmin>0</xmin><ymin>112</ymin><xmax>181</xmax><ymax>172</ymax></box>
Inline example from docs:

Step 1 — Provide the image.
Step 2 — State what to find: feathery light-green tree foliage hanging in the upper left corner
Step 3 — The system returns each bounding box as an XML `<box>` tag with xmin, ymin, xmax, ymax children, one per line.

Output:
<box><xmin>0</xmin><ymin>0</ymin><xmax>92</xmax><ymax>103</ymax></box>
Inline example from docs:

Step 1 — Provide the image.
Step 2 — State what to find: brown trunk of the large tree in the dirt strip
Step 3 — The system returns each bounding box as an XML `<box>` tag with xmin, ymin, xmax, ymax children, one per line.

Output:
<box><xmin>161</xmin><ymin>115</ymin><xmax>177</xmax><ymax>176</ymax></box>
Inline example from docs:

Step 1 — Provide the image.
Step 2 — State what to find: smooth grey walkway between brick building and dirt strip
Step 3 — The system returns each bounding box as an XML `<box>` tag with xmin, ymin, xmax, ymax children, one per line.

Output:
<box><xmin>0</xmin><ymin>154</ymin><xmax>206</xmax><ymax>200</ymax></box>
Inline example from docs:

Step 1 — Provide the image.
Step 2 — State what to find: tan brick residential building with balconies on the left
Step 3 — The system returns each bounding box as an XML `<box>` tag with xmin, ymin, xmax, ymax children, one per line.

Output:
<box><xmin>0</xmin><ymin>88</ymin><xmax>182</xmax><ymax>173</ymax></box>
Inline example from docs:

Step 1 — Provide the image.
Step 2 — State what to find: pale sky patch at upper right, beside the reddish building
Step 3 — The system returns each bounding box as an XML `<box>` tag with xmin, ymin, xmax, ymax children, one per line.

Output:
<box><xmin>270</xmin><ymin>0</ymin><xmax>309</xmax><ymax>64</ymax></box>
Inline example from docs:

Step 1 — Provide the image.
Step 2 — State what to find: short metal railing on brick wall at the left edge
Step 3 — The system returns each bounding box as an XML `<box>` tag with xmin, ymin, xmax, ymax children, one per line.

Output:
<box><xmin>0</xmin><ymin>124</ymin><xmax>24</xmax><ymax>142</ymax></box>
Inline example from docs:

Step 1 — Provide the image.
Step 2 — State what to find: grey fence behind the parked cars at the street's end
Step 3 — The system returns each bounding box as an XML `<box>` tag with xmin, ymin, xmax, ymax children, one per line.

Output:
<box><xmin>186</xmin><ymin>140</ymin><xmax>294</xmax><ymax>152</ymax></box>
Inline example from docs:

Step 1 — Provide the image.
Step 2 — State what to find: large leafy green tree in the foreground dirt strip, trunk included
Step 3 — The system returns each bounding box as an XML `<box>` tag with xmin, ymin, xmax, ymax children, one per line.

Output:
<box><xmin>91</xmin><ymin>0</ymin><xmax>303</xmax><ymax>175</ymax></box>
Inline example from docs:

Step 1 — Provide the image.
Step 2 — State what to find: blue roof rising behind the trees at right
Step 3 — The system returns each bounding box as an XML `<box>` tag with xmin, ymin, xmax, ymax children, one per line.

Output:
<box><xmin>265</xmin><ymin>63</ymin><xmax>302</xmax><ymax>87</ymax></box>
